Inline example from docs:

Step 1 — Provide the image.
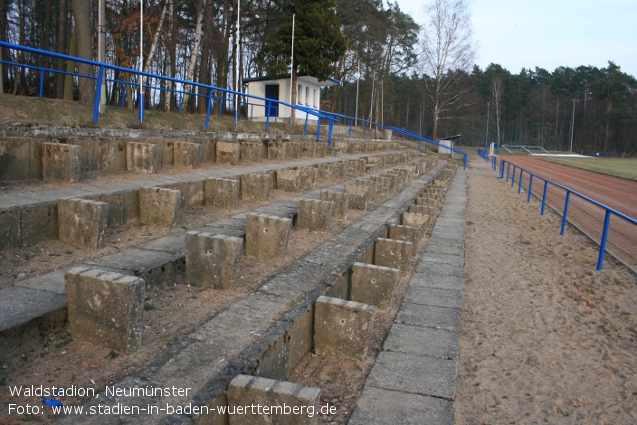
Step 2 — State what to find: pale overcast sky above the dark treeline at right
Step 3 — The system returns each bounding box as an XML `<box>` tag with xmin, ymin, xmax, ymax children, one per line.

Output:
<box><xmin>395</xmin><ymin>0</ymin><xmax>637</xmax><ymax>77</ymax></box>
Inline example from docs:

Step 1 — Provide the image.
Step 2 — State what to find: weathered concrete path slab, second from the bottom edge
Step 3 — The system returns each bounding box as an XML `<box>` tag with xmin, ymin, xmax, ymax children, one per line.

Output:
<box><xmin>367</xmin><ymin>351</ymin><xmax>457</xmax><ymax>400</ymax></box>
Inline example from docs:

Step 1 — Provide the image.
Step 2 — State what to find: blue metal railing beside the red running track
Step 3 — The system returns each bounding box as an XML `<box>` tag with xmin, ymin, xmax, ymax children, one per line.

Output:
<box><xmin>494</xmin><ymin>158</ymin><xmax>637</xmax><ymax>270</ymax></box>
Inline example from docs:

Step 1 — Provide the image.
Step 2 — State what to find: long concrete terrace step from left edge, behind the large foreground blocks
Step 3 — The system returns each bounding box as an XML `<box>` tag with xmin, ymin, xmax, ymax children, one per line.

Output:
<box><xmin>0</xmin><ymin>152</ymin><xmax>432</xmax><ymax>355</ymax></box>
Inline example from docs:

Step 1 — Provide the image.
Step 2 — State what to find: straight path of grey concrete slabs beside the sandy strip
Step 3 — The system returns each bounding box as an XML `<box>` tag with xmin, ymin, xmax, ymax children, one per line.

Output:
<box><xmin>349</xmin><ymin>170</ymin><xmax>467</xmax><ymax>425</ymax></box>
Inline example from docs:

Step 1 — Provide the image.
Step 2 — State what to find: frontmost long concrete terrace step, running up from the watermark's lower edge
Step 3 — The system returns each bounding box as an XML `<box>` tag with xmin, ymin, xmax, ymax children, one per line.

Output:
<box><xmin>46</xmin><ymin>164</ymin><xmax>444</xmax><ymax>424</ymax></box>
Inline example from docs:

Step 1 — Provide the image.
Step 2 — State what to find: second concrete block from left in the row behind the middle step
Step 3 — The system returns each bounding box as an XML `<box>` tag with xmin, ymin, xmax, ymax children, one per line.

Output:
<box><xmin>139</xmin><ymin>187</ymin><xmax>181</xmax><ymax>227</ymax></box>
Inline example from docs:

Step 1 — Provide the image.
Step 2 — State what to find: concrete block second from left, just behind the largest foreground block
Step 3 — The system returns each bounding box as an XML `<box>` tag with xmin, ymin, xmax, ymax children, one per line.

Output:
<box><xmin>186</xmin><ymin>231</ymin><xmax>243</xmax><ymax>290</ymax></box>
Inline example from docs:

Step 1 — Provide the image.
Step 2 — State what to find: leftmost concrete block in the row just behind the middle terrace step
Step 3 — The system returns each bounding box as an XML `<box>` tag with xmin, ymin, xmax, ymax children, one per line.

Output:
<box><xmin>58</xmin><ymin>198</ymin><xmax>108</xmax><ymax>251</ymax></box>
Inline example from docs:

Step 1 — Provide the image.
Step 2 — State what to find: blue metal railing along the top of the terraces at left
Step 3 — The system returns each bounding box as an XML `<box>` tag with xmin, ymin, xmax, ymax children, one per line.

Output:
<box><xmin>0</xmin><ymin>41</ymin><xmax>336</xmax><ymax>146</ymax></box>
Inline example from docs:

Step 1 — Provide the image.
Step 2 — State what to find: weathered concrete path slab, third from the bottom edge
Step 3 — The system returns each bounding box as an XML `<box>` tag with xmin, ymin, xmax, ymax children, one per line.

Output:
<box><xmin>383</xmin><ymin>323</ymin><xmax>459</xmax><ymax>359</ymax></box>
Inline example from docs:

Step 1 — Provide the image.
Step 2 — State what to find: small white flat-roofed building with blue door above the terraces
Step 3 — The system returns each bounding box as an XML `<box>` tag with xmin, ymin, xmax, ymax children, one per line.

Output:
<box><xmin>244</xmin><ymin>75</ymin><xmax>341</xmax><ymax>122</ymax></box>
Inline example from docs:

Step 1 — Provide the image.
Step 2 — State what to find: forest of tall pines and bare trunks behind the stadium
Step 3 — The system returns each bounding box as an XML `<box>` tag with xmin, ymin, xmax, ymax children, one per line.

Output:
<box><xmin>0</xmin><ymin>0</ymin><xmax>637</xmax><ymax>156</ymax></box>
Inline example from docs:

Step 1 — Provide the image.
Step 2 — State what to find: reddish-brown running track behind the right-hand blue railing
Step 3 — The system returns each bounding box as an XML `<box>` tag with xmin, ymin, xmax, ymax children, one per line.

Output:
<box><xmin>498</xmin><ymin>155</ymin><xmax>637</xmax><ymax>270</ymax></box>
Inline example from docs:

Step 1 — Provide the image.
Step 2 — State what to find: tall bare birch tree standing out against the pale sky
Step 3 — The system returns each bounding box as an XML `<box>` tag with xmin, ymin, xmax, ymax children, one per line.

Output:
<box><xmin>421</xmin><ymin>0</ymin><xmax>476</xmax><ymax>139</ymax></box>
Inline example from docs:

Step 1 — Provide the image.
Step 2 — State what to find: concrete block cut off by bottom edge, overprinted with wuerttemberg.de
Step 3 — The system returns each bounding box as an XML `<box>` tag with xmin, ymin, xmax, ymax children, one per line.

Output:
<box><xmin>226</xmin><ymin>375</ymin><xmax>321</xmax><ymax>425</ymax></box>
